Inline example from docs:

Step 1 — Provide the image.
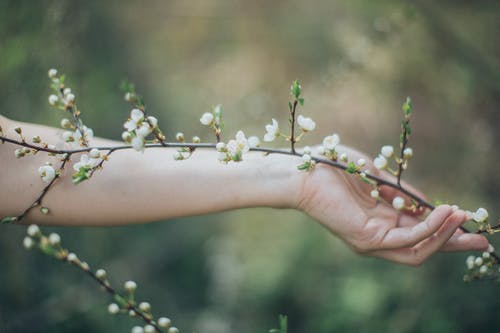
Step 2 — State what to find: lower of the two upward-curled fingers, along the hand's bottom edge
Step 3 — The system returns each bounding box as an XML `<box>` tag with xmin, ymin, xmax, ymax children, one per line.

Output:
<box><xmin>372</xmin><ymin>210</ymin><xmax>468</xmax><ymax>266</ymax></box>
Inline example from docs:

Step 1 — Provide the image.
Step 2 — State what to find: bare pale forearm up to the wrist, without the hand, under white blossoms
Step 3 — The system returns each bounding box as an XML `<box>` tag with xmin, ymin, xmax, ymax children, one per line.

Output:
<box><xmin>0</xmin><ymin>115</ymin><xmax>302</xmax><ymax>225</ymax></box>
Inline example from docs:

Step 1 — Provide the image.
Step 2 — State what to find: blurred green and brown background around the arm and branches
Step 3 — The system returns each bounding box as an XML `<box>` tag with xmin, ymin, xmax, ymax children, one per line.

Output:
<box><xmin>0</xmin><ymin>0</ymin><xmax>500</xmax><ymax>333</ymax></box>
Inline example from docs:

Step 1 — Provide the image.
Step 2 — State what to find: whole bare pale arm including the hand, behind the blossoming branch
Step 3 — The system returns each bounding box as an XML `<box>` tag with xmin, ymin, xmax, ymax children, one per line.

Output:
<box><xmin>0</xmin><ymin>116</ymin><xmax>489</xmax><ymax>265</ymax></box>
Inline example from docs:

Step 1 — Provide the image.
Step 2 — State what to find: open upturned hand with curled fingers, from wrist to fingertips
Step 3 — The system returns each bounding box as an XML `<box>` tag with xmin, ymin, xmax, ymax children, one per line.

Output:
<box><xmin>297</xmin><ymin>147</ymin><xmax>489</xmax><ymax>265</ymax></box>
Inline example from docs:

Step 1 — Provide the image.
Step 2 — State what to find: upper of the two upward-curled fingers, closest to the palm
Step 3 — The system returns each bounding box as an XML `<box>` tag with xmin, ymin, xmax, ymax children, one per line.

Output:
<box><xmin>379</xmin><ymin>205</ymin><xmax>453</xmax><ymax>249</ymax></box>
